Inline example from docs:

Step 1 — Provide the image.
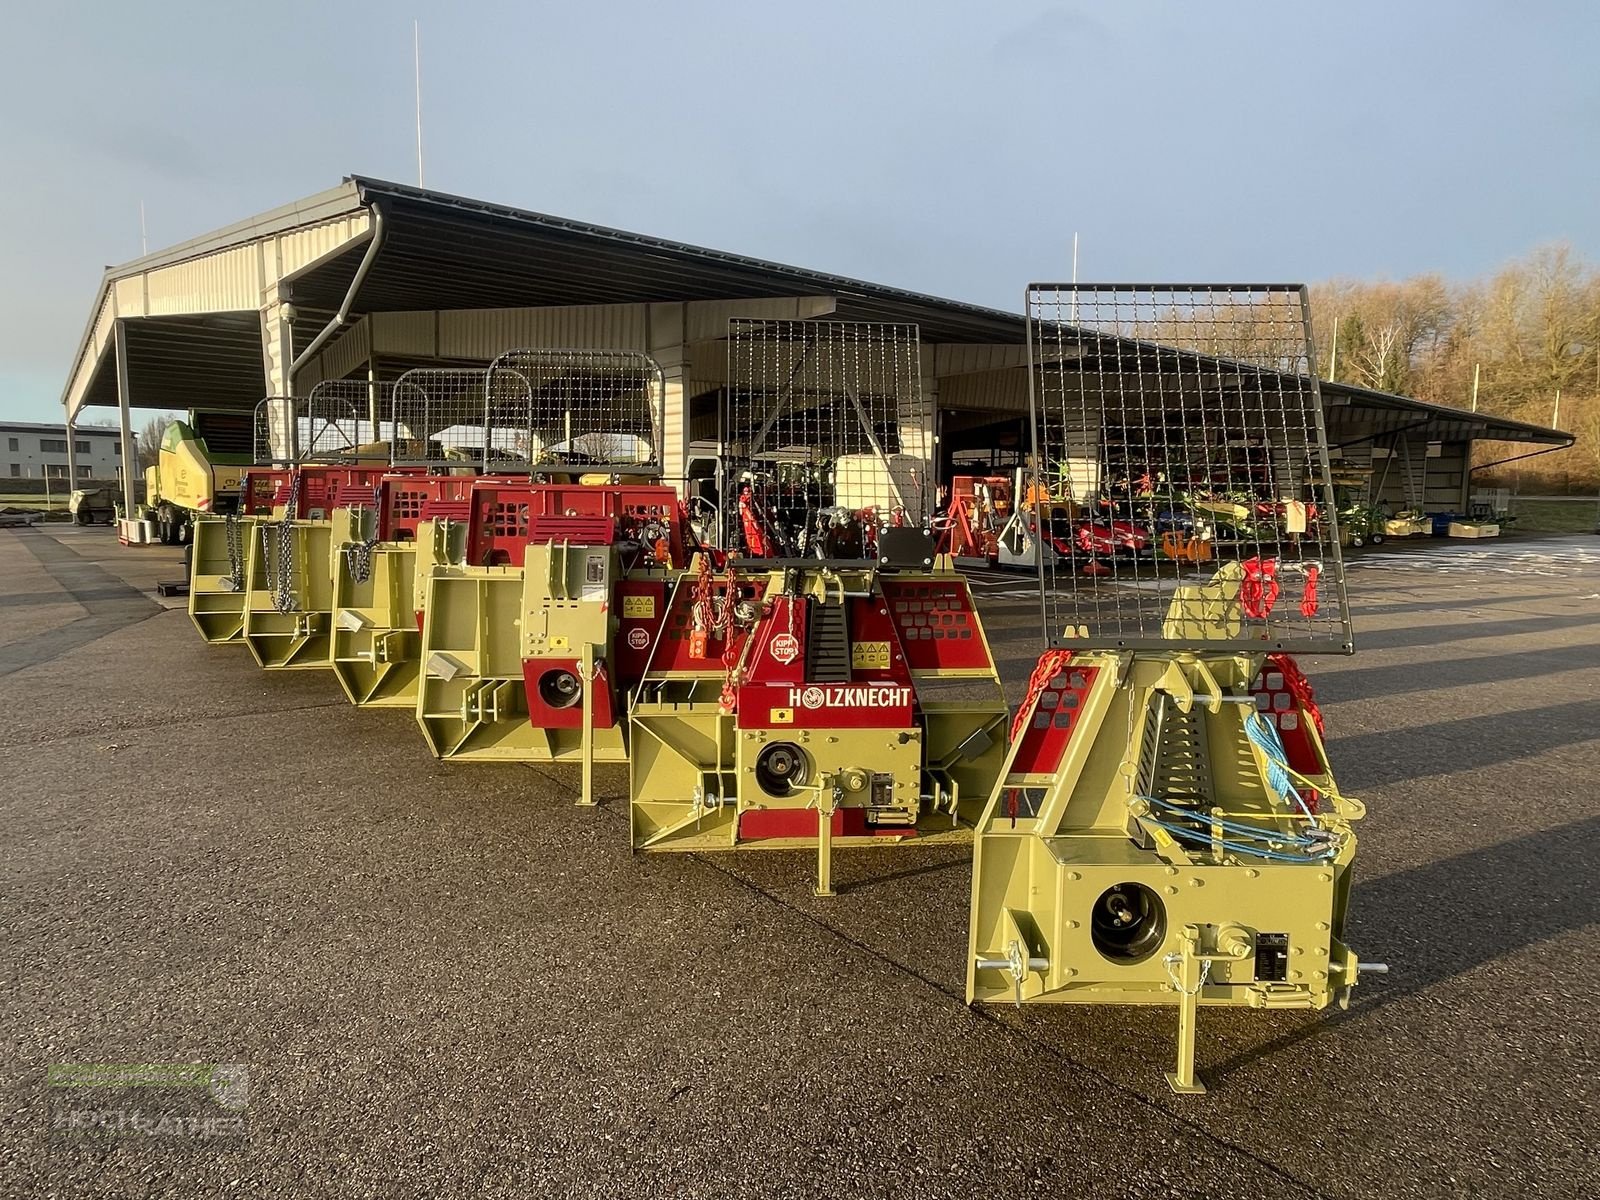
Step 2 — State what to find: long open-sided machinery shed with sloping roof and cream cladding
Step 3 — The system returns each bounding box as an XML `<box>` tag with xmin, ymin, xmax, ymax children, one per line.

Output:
<box><xmin>53</xmin><ymin>176</ymin><xmax>1573</xmax><ymax>510</ymax></box>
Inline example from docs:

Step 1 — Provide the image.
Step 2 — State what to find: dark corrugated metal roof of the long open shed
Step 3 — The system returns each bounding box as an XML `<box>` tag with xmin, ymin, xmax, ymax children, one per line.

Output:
<box><xmin>64</xmin><ymin>176</ymin><xmax>1573</xmax><ymax>445</ymax></box>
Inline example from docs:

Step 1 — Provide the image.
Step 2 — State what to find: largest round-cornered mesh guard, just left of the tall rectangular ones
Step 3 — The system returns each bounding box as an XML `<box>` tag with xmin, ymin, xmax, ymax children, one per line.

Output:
<box><xmin>488</xmin><ymin>349</ymin><xmax>666</xmax><ymax>475</ymax></box>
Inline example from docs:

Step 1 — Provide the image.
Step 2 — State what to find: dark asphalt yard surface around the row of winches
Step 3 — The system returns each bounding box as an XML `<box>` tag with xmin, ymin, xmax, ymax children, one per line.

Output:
<box><xmin>0</xmin><ymin>526</ymin><xmax>1600</xmax><ymax>1197</ymax></box>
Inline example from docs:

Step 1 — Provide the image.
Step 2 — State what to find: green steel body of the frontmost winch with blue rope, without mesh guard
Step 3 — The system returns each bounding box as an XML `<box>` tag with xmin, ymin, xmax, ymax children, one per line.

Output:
<box><xmin>966</xmin><ymin>651</ymin><xmax>1365</xmax><ymax>1093</ymax></box>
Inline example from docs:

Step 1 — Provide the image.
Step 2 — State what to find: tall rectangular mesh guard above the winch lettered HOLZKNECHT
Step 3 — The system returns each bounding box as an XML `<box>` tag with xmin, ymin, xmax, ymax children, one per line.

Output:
<box><xmin>723</xmin><ymin>320</ymin><xmax>936</xmax><ymax>560</ymax></box>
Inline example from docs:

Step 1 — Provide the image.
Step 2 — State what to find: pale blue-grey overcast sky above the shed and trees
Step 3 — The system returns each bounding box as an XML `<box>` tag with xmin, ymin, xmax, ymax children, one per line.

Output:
<box><xmin>0</xmin><ymin>0</ymin><xmax>1600</xmax><ymax>419</ymax></box>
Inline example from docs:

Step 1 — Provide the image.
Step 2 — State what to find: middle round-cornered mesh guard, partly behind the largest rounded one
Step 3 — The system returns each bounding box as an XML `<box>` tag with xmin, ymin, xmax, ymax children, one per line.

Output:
<box><xmin>384</xmin><ymin>366</ymin><xmax>528</xmax><ymax>469</ymax></box>
